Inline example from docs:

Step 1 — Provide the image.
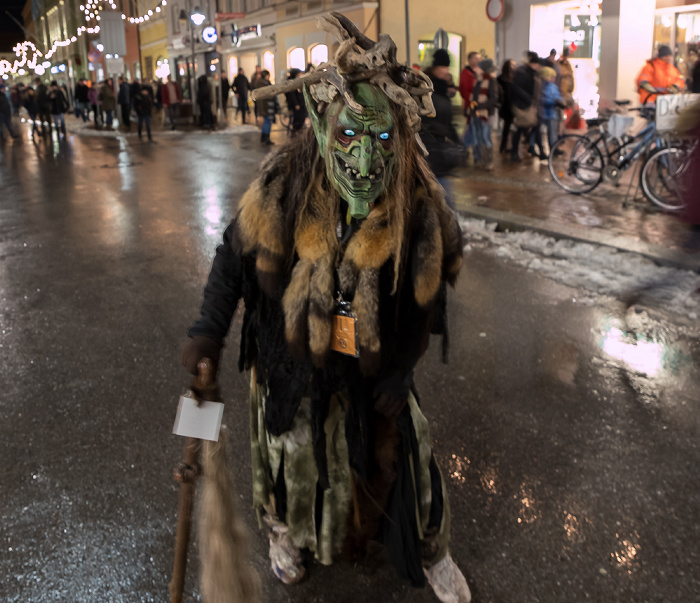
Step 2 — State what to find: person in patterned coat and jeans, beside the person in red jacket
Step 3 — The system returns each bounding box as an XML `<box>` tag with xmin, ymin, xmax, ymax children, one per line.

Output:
<box><xmin>469</xmin><ymin>59</ymin><xmax>498</xmax><ymax>170</ymax></box>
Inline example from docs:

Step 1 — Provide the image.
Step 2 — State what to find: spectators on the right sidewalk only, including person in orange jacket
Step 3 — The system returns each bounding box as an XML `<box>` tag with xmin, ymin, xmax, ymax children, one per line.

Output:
<box><xmin>415</xmin><ymin>45</ymin><xmax>700</xmax><ymax>208</ymax></box>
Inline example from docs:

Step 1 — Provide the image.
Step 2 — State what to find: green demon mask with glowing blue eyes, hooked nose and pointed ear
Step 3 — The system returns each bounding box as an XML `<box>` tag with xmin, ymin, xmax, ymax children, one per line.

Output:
<box><xmin>304</xmin><ymin>83</ymin><xmax>395</xmax><ymax>220</ymax></box>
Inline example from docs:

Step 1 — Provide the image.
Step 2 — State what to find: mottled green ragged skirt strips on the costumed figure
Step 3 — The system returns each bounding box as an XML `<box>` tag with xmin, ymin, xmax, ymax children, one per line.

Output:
<box><xmin>250</xmin><ymin>375</ymin><xmax>450</xmax><ymax>567</ymax></box>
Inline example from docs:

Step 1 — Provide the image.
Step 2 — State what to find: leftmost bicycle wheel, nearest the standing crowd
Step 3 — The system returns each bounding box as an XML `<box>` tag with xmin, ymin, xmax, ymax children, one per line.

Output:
<box><xmin>549</xmin><ymin>135</ymin><xmax>605</xmax><ymax>195</ymax></box>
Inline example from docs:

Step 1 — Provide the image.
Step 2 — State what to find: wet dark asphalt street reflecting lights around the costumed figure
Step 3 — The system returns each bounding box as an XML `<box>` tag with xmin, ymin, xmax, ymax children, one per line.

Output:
<box><xmin>0</xmin><ymin>125</ymin><xmax>700</xmax><ymax>603</ymax></box>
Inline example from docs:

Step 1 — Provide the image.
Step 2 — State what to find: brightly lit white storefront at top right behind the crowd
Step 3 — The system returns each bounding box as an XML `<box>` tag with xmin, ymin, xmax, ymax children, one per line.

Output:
<box><xmin>504</xmin><ymin>0</ymin><xmax>700</xmax><ymax>117</ymax></box>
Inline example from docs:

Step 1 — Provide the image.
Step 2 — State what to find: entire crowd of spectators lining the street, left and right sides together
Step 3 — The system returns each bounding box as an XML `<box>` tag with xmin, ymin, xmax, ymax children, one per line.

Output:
<box><xmin>0</xmin><ymin>46</ymin><xmax>700</xmax><ymax>159</ymax></box>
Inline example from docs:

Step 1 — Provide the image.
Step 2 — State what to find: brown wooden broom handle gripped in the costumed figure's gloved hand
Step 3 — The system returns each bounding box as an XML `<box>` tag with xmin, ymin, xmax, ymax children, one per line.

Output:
<box><xmin>170</xmin><ymin>358</ymin><xmax>216</xmax><ymax>603</ymax></box>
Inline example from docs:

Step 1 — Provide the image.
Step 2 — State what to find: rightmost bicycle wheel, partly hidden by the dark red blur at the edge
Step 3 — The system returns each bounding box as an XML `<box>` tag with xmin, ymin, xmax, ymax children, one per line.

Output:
<box><xmin>640</xmin><ymin>147</ymin><xmax>688</xmax><ymax>211</ymax></box>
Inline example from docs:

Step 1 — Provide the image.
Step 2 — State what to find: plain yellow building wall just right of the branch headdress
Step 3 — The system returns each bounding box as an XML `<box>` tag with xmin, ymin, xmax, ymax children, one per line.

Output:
<box><xmin>380</xmin><ymin>0</ymin><xmax>496</xmax><ymax>68</ymax></box>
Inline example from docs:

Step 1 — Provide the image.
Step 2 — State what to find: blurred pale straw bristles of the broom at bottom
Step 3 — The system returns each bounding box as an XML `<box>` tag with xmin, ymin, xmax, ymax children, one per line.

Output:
<box><xmin>199</xmin><ymin>428</ymin><xmax>260</xmax><ymax>603</ymax></box>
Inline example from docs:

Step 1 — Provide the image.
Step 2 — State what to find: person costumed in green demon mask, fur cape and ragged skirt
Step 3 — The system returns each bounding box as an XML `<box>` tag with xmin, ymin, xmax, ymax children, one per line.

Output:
<box><xmin>183</xmin><ymin>13</ymin><xmax>470</xmax><ymax>603</ymax></box>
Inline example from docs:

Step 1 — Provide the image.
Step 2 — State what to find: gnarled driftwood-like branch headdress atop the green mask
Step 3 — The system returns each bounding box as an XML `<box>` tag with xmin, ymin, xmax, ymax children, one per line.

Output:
<box><xmin>252</xmin><ymin>12</ymin><xmax>435</xmax><ymax>134</ymax></box>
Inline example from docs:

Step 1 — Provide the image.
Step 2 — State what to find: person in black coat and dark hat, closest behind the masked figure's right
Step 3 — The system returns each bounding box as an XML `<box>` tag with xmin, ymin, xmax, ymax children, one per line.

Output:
<box><xmin>421</xmin><ymin>48</ymin><xmax>466</xmax><ymax>209</ymax></box>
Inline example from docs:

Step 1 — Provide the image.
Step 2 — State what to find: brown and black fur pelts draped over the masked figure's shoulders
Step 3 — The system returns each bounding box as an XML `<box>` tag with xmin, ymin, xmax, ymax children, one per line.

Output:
<box><xmin>237</xmin><ymin>105</ymin><xmax>462</xmax><ymax>374</ymax></box>
